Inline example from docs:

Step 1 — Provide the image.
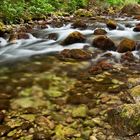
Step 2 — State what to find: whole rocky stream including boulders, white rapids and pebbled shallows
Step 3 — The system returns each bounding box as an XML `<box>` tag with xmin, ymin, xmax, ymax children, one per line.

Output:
<box><xmin>0</xmin><ymin>13</ymin><xmax>140</xmax><ymax>140</ymax></box>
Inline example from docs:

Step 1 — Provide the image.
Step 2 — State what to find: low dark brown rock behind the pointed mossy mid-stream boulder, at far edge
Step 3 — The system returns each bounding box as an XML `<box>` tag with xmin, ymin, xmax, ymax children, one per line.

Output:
<box><xmin>72</xmin><ymin>20</ymin><xmax>87</xmax><ymax>29</ymax></box>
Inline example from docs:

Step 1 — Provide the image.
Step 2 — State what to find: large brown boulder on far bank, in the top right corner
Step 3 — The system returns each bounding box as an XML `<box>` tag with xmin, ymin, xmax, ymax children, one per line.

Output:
<box><xmin>121</xmin><ymin>4</ymin><xmax>140</xmax><ymax>16</ymax></box>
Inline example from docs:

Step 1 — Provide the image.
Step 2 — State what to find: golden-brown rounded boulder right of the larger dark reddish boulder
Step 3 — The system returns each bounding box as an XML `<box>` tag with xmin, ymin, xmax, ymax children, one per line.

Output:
<box><xmin>117</xmin><ymin>38</ymin><xmax>136</xmax><ymax>53</ymax></box>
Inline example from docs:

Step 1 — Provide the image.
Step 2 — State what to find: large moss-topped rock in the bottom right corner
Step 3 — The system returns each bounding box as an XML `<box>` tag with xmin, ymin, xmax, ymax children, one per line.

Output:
<box><xmin>108</xmin><ymin>103</ymin><xmax>140</xmax><ymax>136</ymax></box>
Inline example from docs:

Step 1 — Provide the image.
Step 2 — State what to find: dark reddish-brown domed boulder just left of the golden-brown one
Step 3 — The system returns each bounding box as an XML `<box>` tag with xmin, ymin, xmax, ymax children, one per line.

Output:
<box><xmin>92</xmin><ymin>35</ymin><xmax>116</xmax><ymax>50</ymax></box>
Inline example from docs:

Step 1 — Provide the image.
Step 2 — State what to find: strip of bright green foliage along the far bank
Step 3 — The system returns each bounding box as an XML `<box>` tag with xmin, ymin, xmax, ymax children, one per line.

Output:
<box><xmin>0</xmin><ymin>0</ymin><xmax>140</xmax><ymax>23</ymax></box>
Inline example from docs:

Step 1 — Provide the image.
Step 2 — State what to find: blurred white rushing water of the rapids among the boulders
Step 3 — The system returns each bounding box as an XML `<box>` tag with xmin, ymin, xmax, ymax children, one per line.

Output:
<box><xmin>0</xmin><ymin>20</ymin><xmax>140</xmax><ymax>63</ymax></box>
